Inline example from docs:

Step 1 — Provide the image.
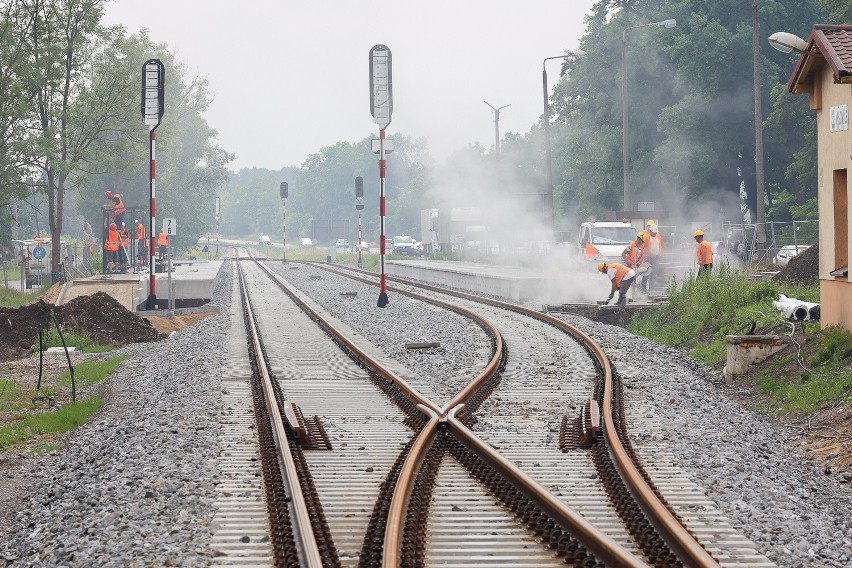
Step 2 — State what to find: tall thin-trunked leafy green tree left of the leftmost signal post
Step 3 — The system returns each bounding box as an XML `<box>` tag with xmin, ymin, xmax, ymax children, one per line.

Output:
<box><xmin>14</xmin><ymin>0</ymin><xmax>131</xmax><ymax>279</ymax></box>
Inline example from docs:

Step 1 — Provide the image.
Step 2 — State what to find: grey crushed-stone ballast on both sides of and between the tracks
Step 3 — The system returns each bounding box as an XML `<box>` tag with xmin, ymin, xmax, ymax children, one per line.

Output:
<box><xmin>0</xmin><ymin>262</ymin><xmax>852</xmax><ymax>567</ymax></box>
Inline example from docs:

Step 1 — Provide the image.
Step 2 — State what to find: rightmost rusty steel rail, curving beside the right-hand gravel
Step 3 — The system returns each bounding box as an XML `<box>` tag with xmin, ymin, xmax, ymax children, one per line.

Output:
<box><xmin>317</xmin><ymin>265</ymin><xmax>719</xmax><ymax>568</ymax></box>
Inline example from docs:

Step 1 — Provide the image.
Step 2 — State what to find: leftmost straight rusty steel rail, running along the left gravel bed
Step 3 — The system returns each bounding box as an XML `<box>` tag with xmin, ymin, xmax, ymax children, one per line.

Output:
<box><xmin>237</xmin><ymin>262</ymin><xmax>322</xmax><ymax>568</ymax></box>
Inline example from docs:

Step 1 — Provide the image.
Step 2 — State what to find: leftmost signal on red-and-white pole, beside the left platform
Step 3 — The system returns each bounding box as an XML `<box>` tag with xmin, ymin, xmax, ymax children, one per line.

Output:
<box><xmin>142</xmin><ymin>59</ymin><xmax>166</xmax><ymax>310</ymax></box>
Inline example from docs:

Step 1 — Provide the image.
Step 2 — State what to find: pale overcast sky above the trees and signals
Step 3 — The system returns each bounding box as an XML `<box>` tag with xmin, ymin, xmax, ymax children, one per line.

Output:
<box><xmin>104</xmin><ymin>0</ymin><xmax>595</xmax><ymax>169</ymax></box>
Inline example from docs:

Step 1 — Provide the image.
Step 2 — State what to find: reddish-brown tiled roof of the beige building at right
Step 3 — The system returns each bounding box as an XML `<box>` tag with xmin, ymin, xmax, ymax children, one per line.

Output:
<box><xmin>787</xmin><ymin>24</ymin><xmax>852</xmax><ymax>93</ymax></box>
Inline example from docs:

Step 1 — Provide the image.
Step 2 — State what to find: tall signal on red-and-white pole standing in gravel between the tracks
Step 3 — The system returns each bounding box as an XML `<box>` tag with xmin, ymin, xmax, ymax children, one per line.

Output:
<box><xmin>370</xmin><ymin>44</ymin><xmax>393</xmax><ymax>308</ymax></box>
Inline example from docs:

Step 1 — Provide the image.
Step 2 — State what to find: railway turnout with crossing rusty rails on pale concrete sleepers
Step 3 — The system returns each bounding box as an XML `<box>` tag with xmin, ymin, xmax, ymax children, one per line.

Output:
<box><xmin>211</xmin><ymin>253</ymin><xmax>772</xmax><ymax>566</ymax></box>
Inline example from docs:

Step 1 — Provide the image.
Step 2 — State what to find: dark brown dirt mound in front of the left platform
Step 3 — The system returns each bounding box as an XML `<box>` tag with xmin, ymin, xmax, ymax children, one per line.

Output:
<box><xmin>0</xmin><ymin>292</ymin><xmax>163</xmax><ymax>361</ymax></box>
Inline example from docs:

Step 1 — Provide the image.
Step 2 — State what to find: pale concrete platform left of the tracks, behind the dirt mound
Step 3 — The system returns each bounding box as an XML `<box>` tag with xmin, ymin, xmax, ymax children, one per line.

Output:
<box><xmin>57</xmin><ymin>260</ymin><xmax>223</xmax><ymax>311</ymax></box>
